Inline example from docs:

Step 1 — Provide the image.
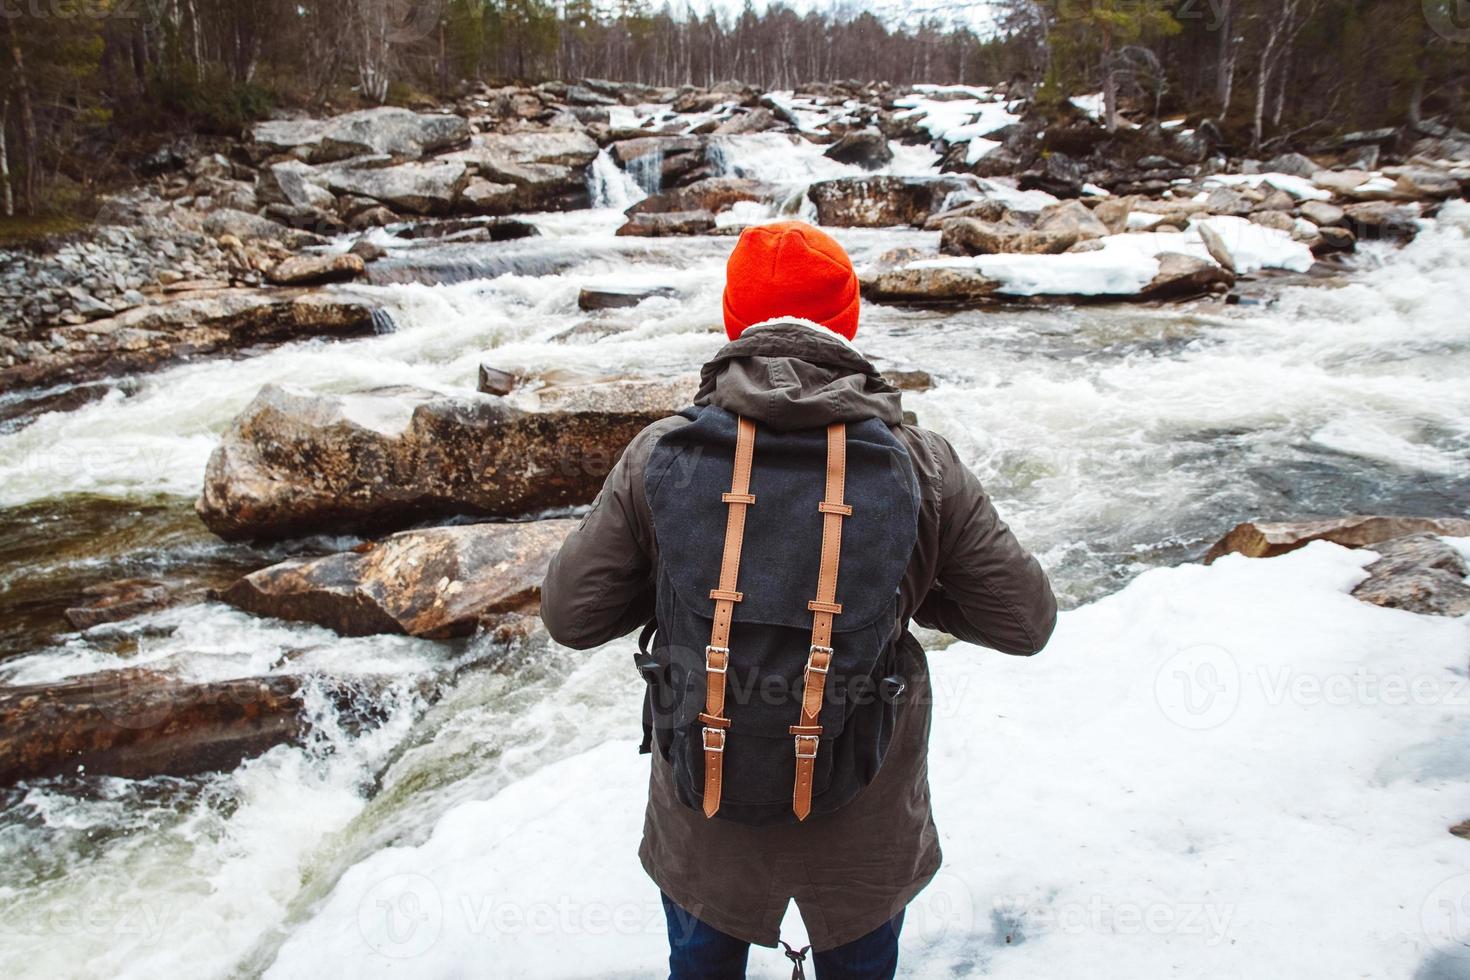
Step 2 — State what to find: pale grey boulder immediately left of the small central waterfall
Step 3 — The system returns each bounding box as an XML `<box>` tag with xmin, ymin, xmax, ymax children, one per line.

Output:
<box><xmin>441</xmin><ymin>129</ymin><xmax>598</xmax><ymax>213</ymax></box>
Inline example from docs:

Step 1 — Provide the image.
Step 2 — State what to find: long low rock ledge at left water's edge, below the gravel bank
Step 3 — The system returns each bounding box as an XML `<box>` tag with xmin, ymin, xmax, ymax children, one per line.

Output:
<box><xmin>0</xmin><ymin>289</ymin><xmax>373</xmax><ymax>389</ymax></box>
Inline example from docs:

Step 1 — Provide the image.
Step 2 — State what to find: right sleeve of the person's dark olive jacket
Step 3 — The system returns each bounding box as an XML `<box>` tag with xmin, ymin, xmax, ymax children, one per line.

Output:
<box><xmin>914</xmin><ymin>436</ymin><xmax>1057</xmax><ymax>657</ymax></box>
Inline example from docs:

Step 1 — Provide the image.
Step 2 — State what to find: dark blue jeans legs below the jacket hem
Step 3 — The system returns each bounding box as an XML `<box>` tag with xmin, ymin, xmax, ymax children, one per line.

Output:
<box><xmin>663</xmin><ymin>895</ymin><xmax>904</xmax><ymax>980</ymax></box>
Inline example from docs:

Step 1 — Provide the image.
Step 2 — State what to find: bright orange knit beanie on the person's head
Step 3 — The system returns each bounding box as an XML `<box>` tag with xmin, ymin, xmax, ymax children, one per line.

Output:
<box><xmin>725</xmin><ymin>222</ymin><xmax>858</xmax><ymax>341</ymax></box>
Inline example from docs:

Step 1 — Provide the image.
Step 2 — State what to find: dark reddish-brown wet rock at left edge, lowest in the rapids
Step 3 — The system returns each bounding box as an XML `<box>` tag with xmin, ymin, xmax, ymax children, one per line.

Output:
<box><xmin>0</xmin><ymin>670</ymin><xmax>303</xmax><ymax>785</ymax></box>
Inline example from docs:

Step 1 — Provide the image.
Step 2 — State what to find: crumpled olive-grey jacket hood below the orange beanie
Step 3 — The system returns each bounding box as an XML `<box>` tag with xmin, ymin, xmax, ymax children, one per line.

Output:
<box><xmin>694</xmin><ymin>320</ymin><xmax>903</xmax><ymax>429</ymax></box>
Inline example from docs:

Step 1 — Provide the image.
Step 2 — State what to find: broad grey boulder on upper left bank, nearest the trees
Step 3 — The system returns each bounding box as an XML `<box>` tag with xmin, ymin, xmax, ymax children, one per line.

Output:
<box><xmin>251</xmin><ymin>106</ymin><xmax>469</xmax><ymax>163</ymax></box>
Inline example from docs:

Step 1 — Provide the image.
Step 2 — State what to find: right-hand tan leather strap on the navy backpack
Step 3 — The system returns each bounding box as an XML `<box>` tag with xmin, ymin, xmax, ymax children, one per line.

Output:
<box><xmin>788</xmin><ymin>422</ymin><xmax>853</xmax><ymax>820</ymax></box>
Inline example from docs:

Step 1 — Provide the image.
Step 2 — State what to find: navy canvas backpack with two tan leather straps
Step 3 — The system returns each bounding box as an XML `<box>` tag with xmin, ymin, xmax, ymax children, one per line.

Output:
<box><xmin>638</xmin><ymin>406</ymin><xmax>919</xmax><ymax>824</ymax></box>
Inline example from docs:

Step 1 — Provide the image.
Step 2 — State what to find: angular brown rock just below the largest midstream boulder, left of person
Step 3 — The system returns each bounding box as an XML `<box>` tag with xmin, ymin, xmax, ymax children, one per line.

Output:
<box><xmin>221</xmin><ymin>520</ymin><xmax>576</xmax><ymax>639</ymax></box>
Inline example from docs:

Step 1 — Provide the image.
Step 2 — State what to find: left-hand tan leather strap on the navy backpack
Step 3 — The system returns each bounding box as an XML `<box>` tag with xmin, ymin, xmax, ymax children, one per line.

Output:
<box><xmin>700</xmin><ymin>419</ymin><xmax>756</xmax><ymax>817</ymax></box>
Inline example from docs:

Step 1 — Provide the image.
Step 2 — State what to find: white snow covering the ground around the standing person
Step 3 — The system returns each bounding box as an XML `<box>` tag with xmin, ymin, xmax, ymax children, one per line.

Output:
<box><xmin>268</xmin><ymin>541</ymin><xmax>1470</xmax><ymax>980</ymax></box>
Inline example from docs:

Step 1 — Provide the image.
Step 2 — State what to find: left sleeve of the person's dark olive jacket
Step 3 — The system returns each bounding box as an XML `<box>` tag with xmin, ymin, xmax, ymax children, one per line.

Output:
<box><xmin>541</xmin><ymin>423</ymin><xmax>662</xmax><ymax>649</ymax></box>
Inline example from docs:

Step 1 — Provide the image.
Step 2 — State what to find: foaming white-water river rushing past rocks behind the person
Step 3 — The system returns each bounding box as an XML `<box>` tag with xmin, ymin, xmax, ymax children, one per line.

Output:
<box><xmin>0</xmin><ymin>141</ymin><xmax>1470</xmax><ymax>977</ymax></box>
